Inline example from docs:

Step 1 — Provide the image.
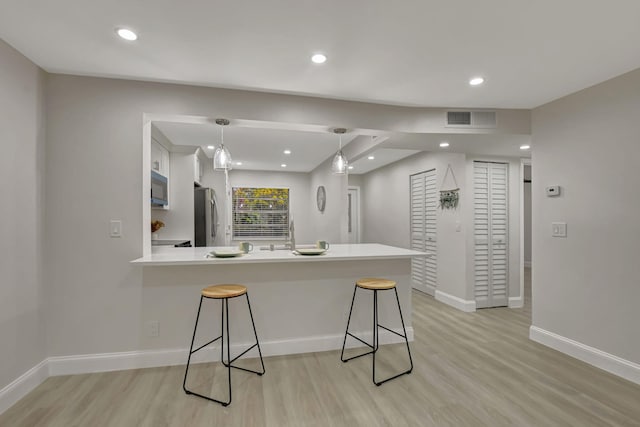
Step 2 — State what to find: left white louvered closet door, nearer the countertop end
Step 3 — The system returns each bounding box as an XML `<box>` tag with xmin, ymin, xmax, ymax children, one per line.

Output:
<box><xmin>411</xmin><ymin>169</ymin><xmax>438</xmax><ymax>295</ymax></box>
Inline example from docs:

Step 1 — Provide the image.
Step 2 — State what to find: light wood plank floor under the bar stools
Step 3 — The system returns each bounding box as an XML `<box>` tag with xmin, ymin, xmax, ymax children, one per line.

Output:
<box><xmin>0</xmin><ymin>270</ymin><xmax>640</xmax><ymax>427</ymax></box>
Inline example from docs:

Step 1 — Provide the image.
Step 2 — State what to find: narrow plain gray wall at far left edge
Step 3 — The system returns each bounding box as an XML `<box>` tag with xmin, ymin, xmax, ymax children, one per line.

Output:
<box><xmin>0</xmin><ymin>40</ymin><xmax>46</xmax><ymax>392</ymax></box>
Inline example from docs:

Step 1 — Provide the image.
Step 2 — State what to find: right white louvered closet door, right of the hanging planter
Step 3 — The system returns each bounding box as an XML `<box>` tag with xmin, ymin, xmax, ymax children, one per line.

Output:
<box><xmin>473</xmin><ymin>162</ymin><xmax>509</xmax><ymax>308</ymax></box>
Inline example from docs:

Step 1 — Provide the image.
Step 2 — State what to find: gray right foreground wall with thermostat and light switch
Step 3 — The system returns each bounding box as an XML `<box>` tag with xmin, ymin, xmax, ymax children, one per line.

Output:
<box><xmin>532</xmin><ymin>70</ymin><xmax>640</xmax><ymax>363</ymax></box>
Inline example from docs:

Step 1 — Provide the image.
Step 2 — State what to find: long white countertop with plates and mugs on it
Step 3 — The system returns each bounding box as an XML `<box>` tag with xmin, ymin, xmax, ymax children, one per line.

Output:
<box><xmin>131</xmin><ymin>243</ymin><xmax>430</xmax><ymax>266</ymax></box>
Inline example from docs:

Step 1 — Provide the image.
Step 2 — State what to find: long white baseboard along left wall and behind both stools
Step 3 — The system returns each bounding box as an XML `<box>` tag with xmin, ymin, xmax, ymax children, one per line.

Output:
<box><xmin>0</xmin><ymin>327</ymin><xmax>413</xmax><ymax>414</ymax></box>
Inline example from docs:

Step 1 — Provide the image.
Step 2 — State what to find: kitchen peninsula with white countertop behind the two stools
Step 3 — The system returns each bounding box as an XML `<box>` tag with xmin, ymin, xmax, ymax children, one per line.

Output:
<box><xmin>132</xmin><ymin>244</ymin><xmax>428</xmax><ymax>357</ymax></box>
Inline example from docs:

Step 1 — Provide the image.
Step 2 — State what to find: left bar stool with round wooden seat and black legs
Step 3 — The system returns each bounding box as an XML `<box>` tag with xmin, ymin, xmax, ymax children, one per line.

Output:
<box><xmin>182</xmin><ymin>284</ymin><xmax>265</xmax><ymax>406</ymax></box>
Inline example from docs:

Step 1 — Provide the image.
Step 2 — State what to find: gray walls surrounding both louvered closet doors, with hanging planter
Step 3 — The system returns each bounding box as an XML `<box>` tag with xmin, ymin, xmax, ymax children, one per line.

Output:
<box><xmin>361</xmin><ymin>152</ymin><xmax>520</xmax><ymax>301</ymax></box>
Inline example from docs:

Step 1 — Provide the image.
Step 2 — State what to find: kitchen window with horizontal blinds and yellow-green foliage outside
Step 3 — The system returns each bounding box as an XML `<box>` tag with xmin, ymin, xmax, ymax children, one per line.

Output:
<box><xmin>233</xmin><ymin>187</ymin><xmax>289</xmax><ymax>240</ymax></box>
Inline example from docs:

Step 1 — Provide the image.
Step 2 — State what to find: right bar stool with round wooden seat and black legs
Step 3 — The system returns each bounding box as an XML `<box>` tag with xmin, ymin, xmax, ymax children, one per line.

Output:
<box><xmin>340</xmin><ymin>278</ymin><xmax>413</xmax><ymax>386</ymax></box>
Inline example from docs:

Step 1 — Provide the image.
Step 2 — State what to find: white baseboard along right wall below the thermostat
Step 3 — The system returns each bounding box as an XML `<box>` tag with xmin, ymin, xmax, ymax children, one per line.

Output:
<box><xmin>529</xmin><ymin>326</ymin><xmax>640</xmax><ymax>384</ymax></box>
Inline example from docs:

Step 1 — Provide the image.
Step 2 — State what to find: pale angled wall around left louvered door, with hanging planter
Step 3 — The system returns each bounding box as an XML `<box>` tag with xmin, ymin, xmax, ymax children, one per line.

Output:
<box><xmin>361</xmin><ymin>152</ymin><xmax>467</xmax><ymax>299</ymax></box>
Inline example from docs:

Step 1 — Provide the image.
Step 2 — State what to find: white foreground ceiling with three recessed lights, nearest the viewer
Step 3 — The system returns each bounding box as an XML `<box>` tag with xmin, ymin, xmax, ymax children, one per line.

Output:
<box><xmin>0</xmin><ymin>0</ymin><xmax>640</xmax><ymax>108</ymax></box>
